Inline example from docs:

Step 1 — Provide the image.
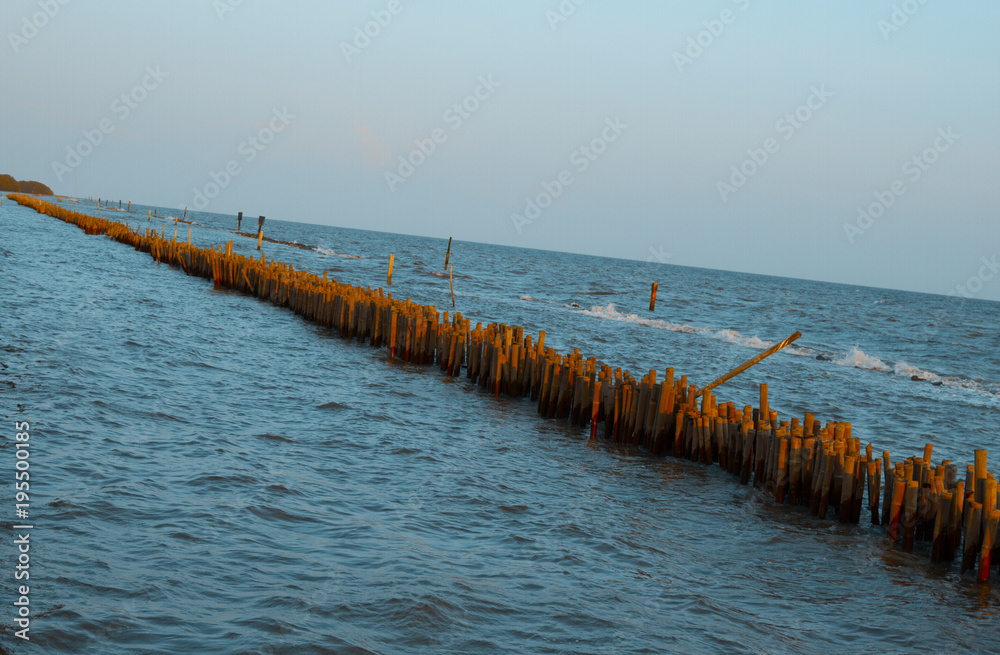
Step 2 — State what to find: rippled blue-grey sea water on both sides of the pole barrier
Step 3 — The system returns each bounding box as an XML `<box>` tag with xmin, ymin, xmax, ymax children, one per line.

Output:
<box><xmin>0</xmin><ymin>200</ymin><xmax>1000</xmax><ymax>655</ymax></box>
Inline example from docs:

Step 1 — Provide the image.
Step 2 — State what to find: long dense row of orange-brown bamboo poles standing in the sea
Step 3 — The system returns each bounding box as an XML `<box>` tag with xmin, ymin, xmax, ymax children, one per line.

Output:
<box><xmin>9</xmin><ymin>194</ymin><xmax>1000</xmax><ymax>582</ymax></box>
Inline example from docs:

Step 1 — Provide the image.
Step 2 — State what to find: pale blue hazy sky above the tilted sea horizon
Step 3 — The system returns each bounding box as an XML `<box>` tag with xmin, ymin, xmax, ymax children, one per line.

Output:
<box><xmin>0</xmin><ymin>0</ymin><xmax>1000</xmax><ymax>300</ymax></box>
